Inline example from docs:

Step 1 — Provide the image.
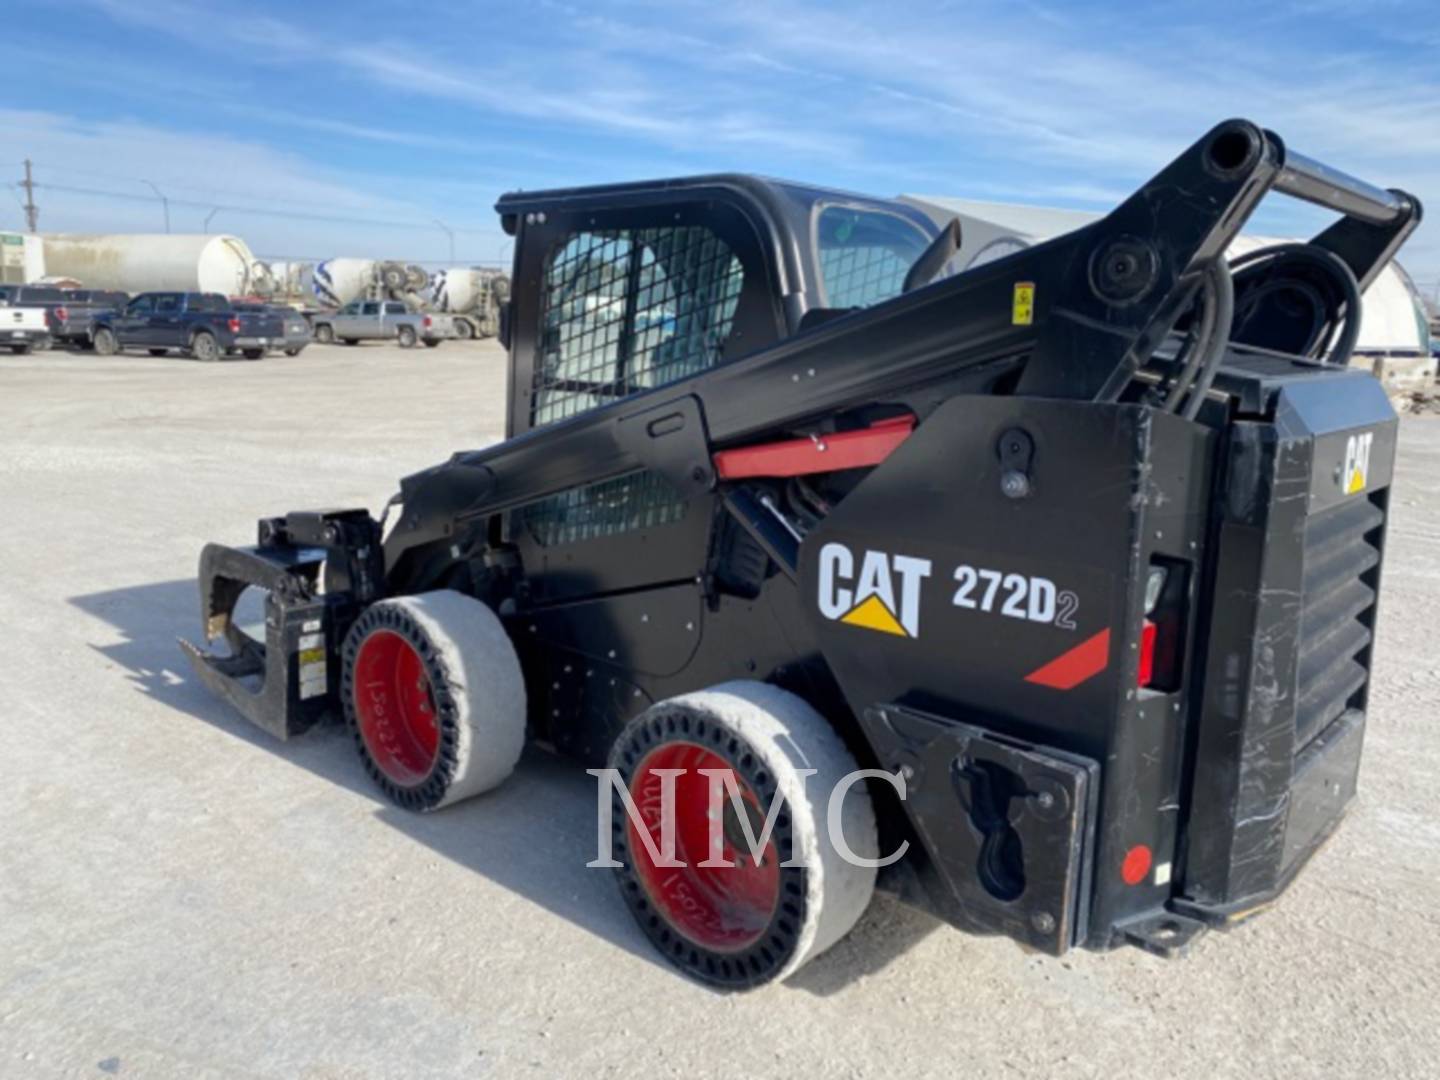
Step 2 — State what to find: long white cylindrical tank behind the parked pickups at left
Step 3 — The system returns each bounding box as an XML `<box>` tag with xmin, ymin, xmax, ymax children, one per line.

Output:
<box><xmin>45</xmin><ymin>233</ymin><xmax>256</xmax><ymax>297</ymax></box>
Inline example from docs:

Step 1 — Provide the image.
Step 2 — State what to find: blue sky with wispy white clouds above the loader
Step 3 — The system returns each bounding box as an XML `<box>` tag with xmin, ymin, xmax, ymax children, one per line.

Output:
<box><xmin>0</xmin><ymin>0</ymin><xmax>1440</xmax><ymax>282</ymax></box>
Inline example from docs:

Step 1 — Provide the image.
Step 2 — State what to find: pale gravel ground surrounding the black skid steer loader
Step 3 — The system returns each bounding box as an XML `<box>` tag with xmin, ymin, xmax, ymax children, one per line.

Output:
<box><xmin>0</xmin><ymin>344</ymin><xmax>1440</xmax><ymax>1080</ymax></box>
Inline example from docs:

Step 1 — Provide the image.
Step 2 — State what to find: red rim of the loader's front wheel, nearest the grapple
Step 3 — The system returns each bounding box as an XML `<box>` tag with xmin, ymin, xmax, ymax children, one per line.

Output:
<box><xmin>354</xmin><ymin>629</ymin><xmax>441</xmax><ymax>786</ymax></box>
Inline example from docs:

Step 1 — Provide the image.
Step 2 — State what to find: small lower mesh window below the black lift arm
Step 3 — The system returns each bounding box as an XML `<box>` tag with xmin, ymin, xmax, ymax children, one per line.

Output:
<box><xmin>520</xmin><ymin>472</ymin><xmax>685</xmax><ymax>547</ymax></box>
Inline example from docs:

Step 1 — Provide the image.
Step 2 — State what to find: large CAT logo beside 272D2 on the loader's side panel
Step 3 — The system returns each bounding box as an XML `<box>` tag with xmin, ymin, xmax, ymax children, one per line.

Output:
<box><xmin>818</xmin><ymin>543</ymin><xmax>930</xmax><ymax>638</ymax></box>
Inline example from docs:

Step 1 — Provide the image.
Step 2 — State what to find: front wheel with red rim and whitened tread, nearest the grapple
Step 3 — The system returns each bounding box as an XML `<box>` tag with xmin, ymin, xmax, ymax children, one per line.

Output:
<box><xmin>340</xmin><ymin>589</ymin><xmax>526</xmax><ymax>811</ymax></box>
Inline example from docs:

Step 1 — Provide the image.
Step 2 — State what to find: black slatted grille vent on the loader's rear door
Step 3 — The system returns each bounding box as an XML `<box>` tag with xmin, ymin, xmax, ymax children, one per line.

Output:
<box><xmin>1295</xmin><ymin>492</ymin><xmax>1385</xmax><ymax>753</ymax></box>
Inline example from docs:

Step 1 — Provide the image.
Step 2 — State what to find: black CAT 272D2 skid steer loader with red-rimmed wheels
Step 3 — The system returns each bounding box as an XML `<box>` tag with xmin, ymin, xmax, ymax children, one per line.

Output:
<box><xmin>187</xmin><ymin>120</ymin><xmax>1421</xmax><ymax>988</ymax></box>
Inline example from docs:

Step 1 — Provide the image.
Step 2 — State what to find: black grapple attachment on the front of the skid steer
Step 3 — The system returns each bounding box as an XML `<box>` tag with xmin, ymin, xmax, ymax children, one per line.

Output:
<box><xmin>180</xmin><ymin>510</ymin><xmax>384</xmax><ymax>739</ymax></box>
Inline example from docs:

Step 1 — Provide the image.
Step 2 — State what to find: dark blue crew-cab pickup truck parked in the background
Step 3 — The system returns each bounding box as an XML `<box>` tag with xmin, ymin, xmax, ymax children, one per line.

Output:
<box><xmin>92</xmin><ymin>292</ymin><xmax>285</xmax><ymax>360</ymax></box>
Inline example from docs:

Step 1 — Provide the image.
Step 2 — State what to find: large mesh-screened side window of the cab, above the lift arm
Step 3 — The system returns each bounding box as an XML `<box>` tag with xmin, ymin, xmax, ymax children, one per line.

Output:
<box><xmin>530</xmin><ymin>226</ymin><xmax>744</xmax><ymax>425</ymax></box>
